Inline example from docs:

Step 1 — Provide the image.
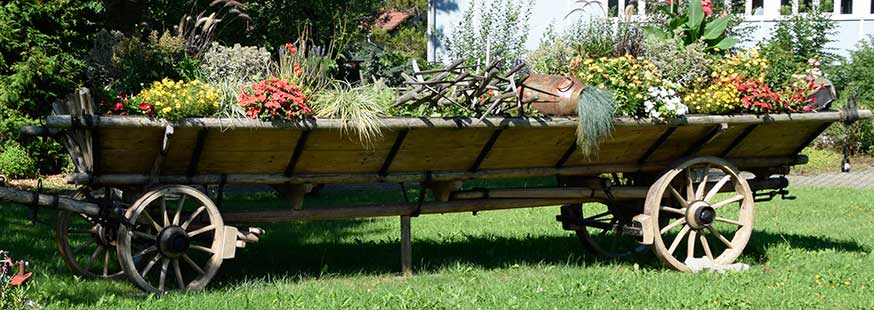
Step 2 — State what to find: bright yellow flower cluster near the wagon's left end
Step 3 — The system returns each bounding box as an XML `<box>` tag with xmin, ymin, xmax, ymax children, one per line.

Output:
<box><xmin>138</xmin><ymin>79</ymin><xmax>221</xmax><ymax>120</ymax></box>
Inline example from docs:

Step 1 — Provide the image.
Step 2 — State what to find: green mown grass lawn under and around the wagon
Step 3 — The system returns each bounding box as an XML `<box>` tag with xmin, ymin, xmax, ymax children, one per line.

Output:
<box><xmin>0</xmin><ymin>188</ymin><xmax>874</xmax><ymax>310</ymax></box>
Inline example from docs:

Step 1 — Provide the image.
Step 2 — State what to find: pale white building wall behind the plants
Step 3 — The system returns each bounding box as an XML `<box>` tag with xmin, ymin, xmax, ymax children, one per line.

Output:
<box><xmin>428</xmin><ymin>0</ymin><xmax>874</xmax><ymax>61</ymax></box>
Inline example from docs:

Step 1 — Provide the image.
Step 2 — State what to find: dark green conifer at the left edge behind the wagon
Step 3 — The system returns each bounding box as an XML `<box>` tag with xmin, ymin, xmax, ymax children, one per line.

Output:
<box><xmin>0</xmin><ymin>0</ymin><xmax>103</xmax><ymax>173</ymax></box>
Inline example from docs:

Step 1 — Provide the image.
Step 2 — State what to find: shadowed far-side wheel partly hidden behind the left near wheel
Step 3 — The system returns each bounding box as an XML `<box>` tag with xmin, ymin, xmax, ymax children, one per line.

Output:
<box><xmin>55</xmin><ymin>187</ymin><xmax>124</xmax><ymax>279</ymax></box>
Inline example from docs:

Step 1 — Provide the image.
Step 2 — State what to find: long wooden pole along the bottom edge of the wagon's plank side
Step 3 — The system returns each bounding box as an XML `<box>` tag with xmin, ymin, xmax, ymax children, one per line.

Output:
<box><xmin>67</xmin><ymin>155</ymin><xmax>807</xmax><ymax>185</ymax></box>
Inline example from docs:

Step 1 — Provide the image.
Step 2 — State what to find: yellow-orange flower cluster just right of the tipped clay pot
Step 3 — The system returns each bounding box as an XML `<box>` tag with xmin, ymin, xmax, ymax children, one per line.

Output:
<box><xmin>570</xmin><ymin>55</ymin><xmax>662</xmax><ymax>115</ymax></box>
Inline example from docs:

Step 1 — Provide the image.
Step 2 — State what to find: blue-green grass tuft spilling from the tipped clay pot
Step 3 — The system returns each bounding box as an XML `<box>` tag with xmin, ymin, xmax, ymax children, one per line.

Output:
<box><xmin>577</xmin><ymin>87</ymin><xmax>616</xmax><ymax>157</ymax></box>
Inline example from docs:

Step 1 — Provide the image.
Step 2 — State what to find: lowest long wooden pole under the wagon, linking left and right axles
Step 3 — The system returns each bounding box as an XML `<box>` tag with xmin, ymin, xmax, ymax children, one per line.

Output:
<box><xmin>222</xmin><ymin>198</ymin><xmax>592</xmax><ymax>224</ymax></box>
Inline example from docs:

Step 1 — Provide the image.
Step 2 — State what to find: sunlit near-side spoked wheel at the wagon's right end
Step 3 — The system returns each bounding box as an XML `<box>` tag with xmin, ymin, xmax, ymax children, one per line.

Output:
<box><xmin>644</xmin><ymin>157</ymin><xmax>754</xmax><ymax>271</ymax></box>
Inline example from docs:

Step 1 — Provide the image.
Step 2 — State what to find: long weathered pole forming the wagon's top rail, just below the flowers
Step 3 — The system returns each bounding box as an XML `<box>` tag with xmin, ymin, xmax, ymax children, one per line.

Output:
<box><xmin>46</xmin><ymin>110</ymin><xmax>874</xmax><ymax>129</ymax></box>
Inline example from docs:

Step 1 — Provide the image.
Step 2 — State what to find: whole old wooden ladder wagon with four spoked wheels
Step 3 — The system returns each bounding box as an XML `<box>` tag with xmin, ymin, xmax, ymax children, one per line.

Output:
<box><xmin>0</xmin><ymin>91</ymin><xmax>874</xmax><ymax>292</ymax></box>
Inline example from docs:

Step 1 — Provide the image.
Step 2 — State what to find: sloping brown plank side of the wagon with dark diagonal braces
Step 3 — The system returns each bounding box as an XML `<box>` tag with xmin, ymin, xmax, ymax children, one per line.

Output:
<box><xmin>48</xmin><ymin>111</ymin><xmax>871</xmax><ymax>183</ymax></box>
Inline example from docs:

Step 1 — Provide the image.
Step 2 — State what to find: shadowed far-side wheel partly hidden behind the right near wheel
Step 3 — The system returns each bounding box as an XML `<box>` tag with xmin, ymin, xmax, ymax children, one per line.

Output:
<box><xmin>561</xmin><ymin>201</ymin><xmax>649</xmax><ymax>258</ymax></box>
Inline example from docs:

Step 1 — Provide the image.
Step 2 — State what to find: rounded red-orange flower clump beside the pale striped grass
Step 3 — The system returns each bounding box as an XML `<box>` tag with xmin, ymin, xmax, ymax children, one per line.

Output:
<box><xmin>239</xmin><ymin>77</ymin><xmax>313</xmax><ymax>120</ymax></box>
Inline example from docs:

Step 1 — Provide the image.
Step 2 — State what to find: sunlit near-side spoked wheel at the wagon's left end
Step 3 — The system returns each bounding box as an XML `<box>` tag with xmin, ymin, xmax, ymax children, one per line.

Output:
<box><xmin>118</xmin><ymin>185</ymin><xmax>225</xmax><ymax>293</ymax></box>
